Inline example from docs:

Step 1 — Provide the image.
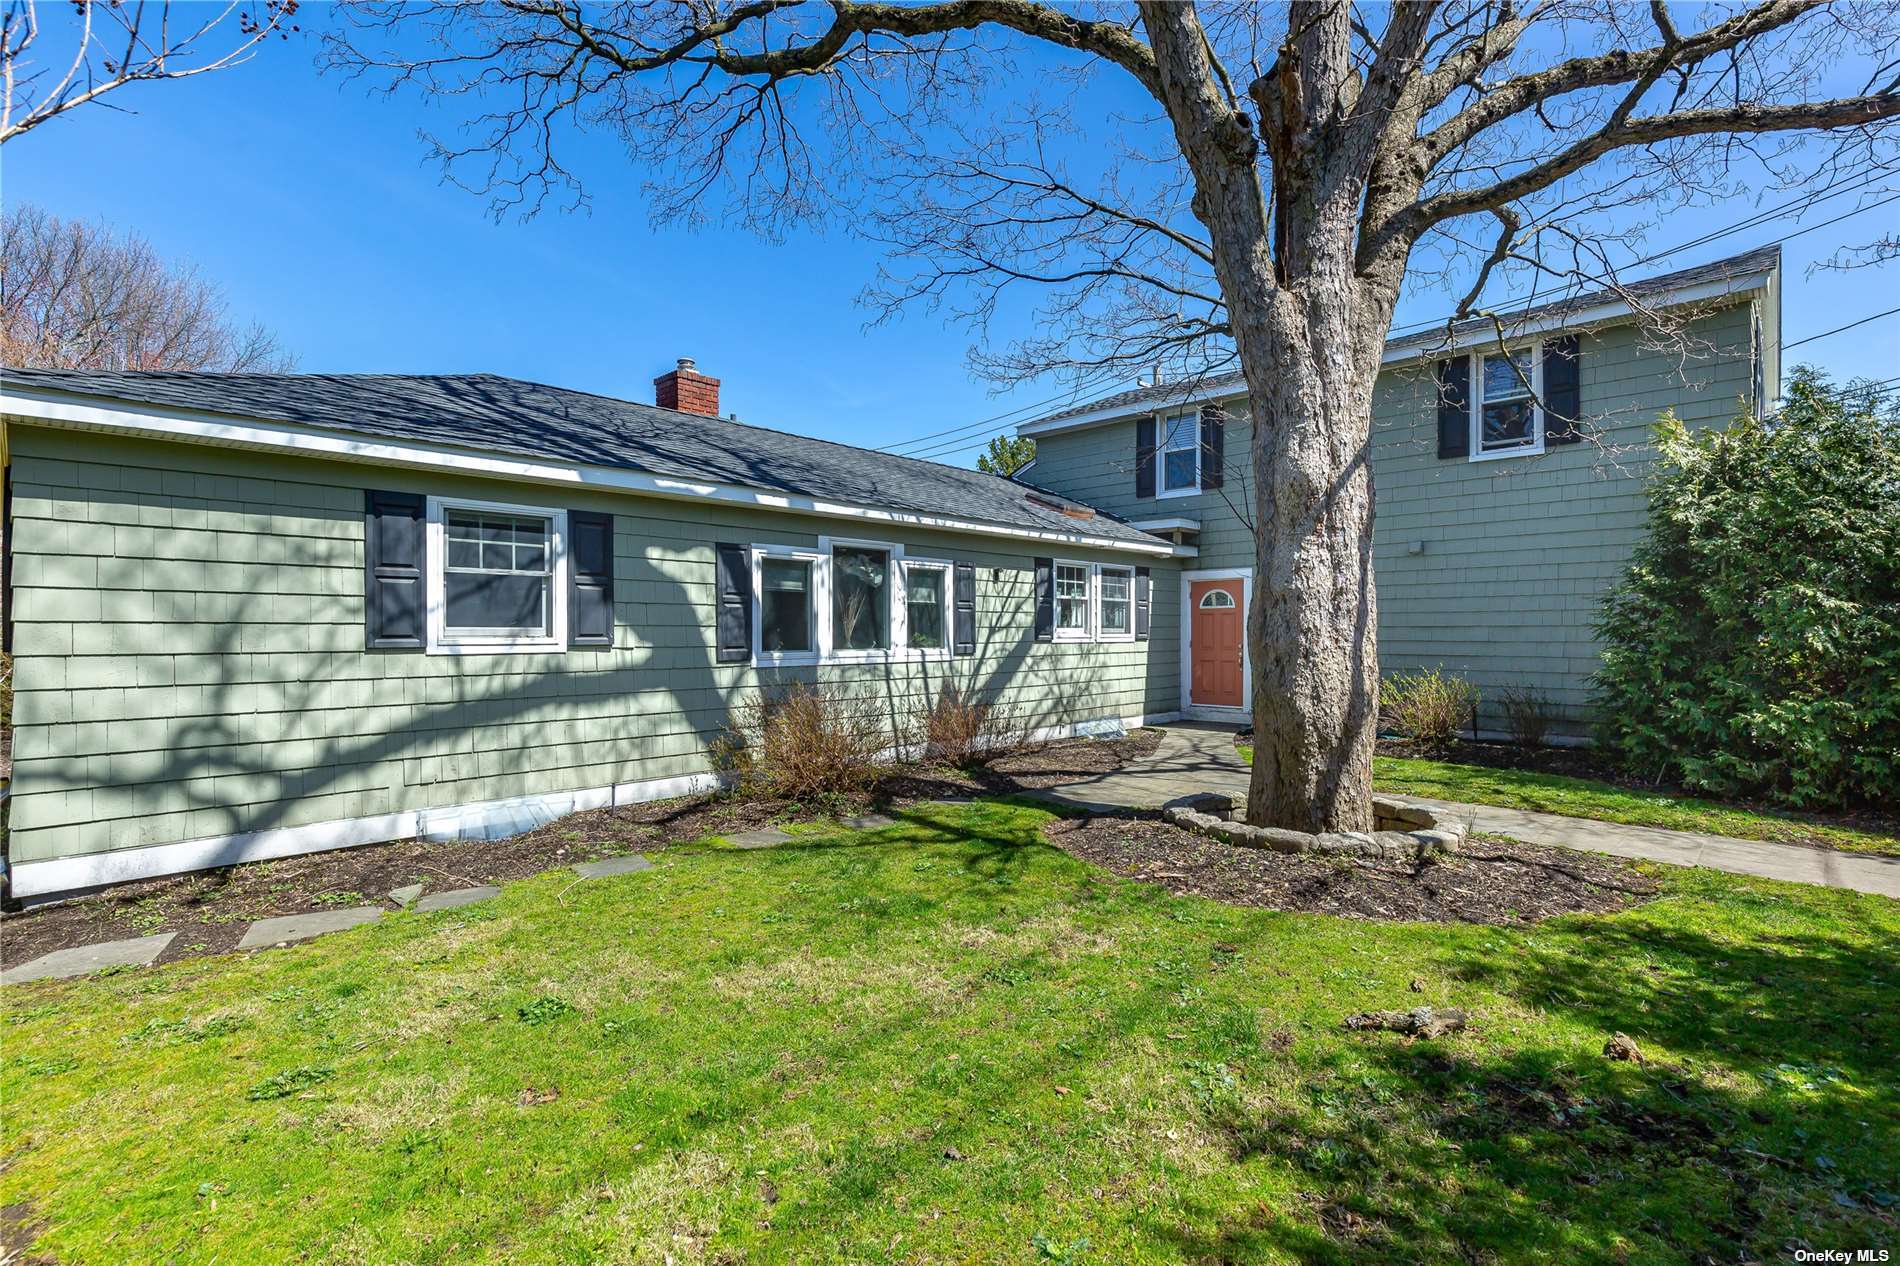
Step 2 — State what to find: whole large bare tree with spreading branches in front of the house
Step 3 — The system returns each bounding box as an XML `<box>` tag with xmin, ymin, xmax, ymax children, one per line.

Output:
<box><xmin>327</xmin><ymin>0</ymin><xmax>1900</xmax><ymax>831</ymax></box>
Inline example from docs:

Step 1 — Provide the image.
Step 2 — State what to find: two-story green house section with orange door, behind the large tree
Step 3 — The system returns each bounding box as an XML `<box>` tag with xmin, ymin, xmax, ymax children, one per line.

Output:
<box><xmin>1018</xmin><ymin>247</ymin><xmax>1780</xmax><ymax>734</ymax></box>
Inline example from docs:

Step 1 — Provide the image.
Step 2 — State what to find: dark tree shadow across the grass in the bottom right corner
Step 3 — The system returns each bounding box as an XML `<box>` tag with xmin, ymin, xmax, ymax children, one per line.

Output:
<box><xmin>1169</xmin><ymin>918</ymin><xmax>1900</xmax><ymax>1266</ymax></box>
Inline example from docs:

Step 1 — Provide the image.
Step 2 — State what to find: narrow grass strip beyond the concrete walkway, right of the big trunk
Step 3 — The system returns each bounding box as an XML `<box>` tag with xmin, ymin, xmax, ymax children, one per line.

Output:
<box><xmin>1241</xmin><ymin>743</ymin><xmax>1900</xmax><ymax>857</ymax></box>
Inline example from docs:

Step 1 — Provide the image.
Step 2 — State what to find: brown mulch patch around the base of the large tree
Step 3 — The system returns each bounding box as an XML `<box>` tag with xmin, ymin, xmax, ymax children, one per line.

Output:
<box><xmin>1045</xmin><ymin>815</ymin><xmax>1657</xmax><ymax>924</ymax></box>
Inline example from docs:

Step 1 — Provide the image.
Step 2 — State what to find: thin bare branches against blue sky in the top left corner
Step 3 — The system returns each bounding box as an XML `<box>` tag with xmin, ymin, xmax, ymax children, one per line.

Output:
<box><xmin>0</xmin><ymin>0</ymin><xmax>298</xmax><ymax>144</ymax></box>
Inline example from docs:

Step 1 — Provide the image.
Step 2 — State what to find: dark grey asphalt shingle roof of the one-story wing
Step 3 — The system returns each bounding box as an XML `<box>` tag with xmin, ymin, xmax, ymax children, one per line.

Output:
<box><xmin>0</xmin><ymin>369</ymin><xmax>1157</xmax><ymax>546</ymax></box>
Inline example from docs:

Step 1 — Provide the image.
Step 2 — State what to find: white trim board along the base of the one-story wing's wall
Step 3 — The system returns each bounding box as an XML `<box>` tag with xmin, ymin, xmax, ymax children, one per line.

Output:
<box><xmin>11</xmin><ymin>713</ymin><xmax>1180</xmax><ymax>901</ymax></box>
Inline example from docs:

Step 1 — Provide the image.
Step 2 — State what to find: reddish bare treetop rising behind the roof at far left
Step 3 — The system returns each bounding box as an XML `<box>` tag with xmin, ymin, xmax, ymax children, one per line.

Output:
<box><xmin>0</xmin><ymin>205</ymin><xmax>295</xmax><ymax>371</ymax></box>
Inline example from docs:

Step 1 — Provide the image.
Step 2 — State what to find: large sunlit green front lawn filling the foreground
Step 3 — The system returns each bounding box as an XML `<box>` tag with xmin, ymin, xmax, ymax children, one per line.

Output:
<box><xmin>0</xmin><ymin>802</ymin><xmax>1900</xmax><ymax>1264</ymax></box>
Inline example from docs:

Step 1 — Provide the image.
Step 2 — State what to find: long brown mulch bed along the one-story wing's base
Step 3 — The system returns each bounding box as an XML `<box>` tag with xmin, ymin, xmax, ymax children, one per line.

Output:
<box><xmin>0</xmin><ymin>730</ymin><xmax>1161</xmax><ymax>968</ymax></box>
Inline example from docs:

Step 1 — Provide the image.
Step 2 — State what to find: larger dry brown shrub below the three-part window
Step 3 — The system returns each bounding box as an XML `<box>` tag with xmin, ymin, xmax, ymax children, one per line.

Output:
<box><xmin>707</xmin><ymin>682</ymin><xmax>891</xmax><ymax>800</ymax></box>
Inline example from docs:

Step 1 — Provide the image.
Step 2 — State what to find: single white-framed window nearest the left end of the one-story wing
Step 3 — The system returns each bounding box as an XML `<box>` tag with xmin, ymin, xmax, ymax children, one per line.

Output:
<box><xmin>428</xmin><ymin>496</ymin><xmax>568</xmax><ymax>654</ymax></box>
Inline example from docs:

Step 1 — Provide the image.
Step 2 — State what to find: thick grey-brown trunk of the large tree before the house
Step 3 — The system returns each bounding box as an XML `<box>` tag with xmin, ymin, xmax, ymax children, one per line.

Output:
<box><xmin>1142</xmin><ymin>0</ymin><xmax>1404</xmax><ymax>831</ymax></box>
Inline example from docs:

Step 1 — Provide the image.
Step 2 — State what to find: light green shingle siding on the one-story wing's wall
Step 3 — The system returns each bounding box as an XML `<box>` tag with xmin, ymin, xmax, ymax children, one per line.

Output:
<box><xmin>10</xmin><ymin>426</ymin><xmax>1180</xmax><ymax>863</ymax></box>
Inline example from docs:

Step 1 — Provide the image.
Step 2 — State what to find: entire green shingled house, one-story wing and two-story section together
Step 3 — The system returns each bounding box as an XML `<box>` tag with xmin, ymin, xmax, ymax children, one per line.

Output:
<box><xmin>0</xmin><ymin>257</ymin><xmax>1777</xmax><ymax>897</ymax></box>
